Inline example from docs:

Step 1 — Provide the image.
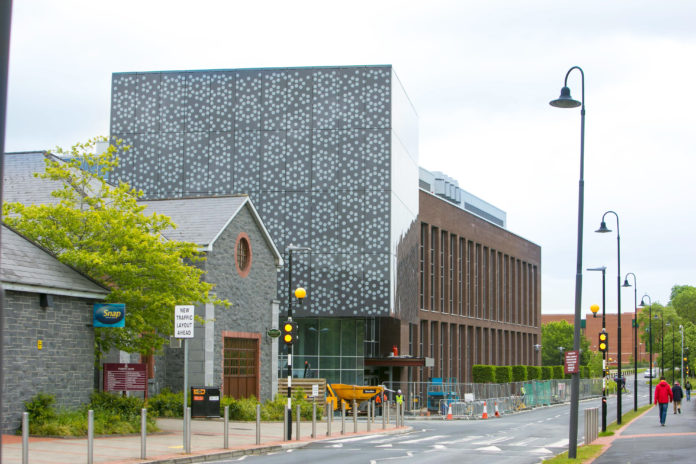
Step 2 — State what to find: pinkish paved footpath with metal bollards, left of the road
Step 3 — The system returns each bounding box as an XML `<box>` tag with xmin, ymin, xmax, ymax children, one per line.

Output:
<box><xmin>1</xmin><ymin>416</ymin><xmax>411</xmax><ymax>464</ymax></box>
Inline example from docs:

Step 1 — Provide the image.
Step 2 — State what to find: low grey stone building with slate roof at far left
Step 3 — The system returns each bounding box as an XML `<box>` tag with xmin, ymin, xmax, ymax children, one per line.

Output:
<box><xmin>0</xmin><ymin>225</ymin><xmax>109</xmax><ymax>433</ymax></box>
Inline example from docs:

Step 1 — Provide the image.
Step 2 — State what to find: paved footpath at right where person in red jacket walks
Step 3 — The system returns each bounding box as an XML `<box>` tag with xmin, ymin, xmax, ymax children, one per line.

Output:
<box><xmin>592</xmin><ymin>395</ymin><xmax>696</xmax><ymax>464</ymax></box>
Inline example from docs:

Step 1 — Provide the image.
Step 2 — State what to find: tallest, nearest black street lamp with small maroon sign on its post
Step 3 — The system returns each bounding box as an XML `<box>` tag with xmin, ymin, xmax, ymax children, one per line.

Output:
<box><xmin>549</xmin><ymin>66</ymin><xmax>585</xmax><ymax>459</ymax></box>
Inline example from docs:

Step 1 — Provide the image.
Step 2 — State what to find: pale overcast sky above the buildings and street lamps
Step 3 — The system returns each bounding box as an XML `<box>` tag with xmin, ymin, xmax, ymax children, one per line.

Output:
<box><xmin>6</xmin><ymin>0</ymin><xmax>696</xmax><ymax>313</ymax></box>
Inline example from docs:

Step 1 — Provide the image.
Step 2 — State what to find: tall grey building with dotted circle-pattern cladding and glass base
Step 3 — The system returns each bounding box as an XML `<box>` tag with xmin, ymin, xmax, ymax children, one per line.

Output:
<box><xmin>111</xmin><ymin>66</ymin><xmax>419</xmax><ymax>383</ymax></box>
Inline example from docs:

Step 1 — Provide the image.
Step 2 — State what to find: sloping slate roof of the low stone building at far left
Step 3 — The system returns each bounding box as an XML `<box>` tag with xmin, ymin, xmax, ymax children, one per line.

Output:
<box><xmin>0</xmin><ymin>225</ymin><xmax>109</xmax><ymax>299</ymax></box>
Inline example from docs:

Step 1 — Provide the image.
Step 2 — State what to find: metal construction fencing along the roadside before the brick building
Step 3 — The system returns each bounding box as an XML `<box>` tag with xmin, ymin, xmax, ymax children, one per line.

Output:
<box><xmin>384</xmin><ymin>378</ymin><xmax>602</xmax><ymax>419</ymax></box>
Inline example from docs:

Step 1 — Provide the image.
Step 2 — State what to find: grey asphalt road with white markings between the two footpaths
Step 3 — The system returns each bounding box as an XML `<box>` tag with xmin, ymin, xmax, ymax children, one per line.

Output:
<box><xmin>211</xmin><ymin>376</ymin><xmax>648</xmax><ymax>464</ymax></box>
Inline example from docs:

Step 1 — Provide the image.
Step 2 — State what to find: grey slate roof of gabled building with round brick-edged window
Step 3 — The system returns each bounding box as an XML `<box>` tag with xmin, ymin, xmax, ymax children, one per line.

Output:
<box><xmin>139</xmin><ymin>195</ymin><xmax>283</xmax><ymax>266</ymax></box>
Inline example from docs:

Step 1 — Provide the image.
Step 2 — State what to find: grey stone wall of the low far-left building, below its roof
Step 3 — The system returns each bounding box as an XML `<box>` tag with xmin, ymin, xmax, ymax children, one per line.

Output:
<box><xmin>2</xmin><ymin>291</ymin><xmax>94</xmax><ymax>433</ymax></box>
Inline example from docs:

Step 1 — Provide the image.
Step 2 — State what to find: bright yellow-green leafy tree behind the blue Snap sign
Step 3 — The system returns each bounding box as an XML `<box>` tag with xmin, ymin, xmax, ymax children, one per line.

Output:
<box><xmin>3</xmin><ymin>137</ymin><xmax>229</xmax><ymax>358</ymax></box>
